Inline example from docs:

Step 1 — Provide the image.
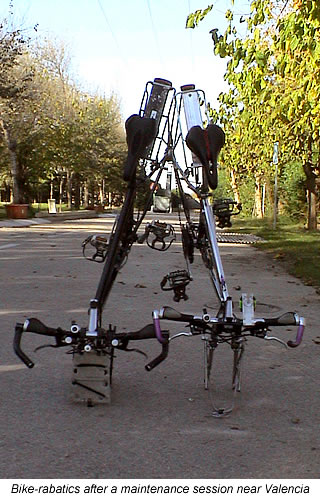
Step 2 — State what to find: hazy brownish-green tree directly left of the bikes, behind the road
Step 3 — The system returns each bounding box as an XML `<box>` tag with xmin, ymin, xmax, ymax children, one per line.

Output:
<box><xmin>27</xmin><ymin>40</ymin><xmax>126</xmax><ymax>207</ymax></box>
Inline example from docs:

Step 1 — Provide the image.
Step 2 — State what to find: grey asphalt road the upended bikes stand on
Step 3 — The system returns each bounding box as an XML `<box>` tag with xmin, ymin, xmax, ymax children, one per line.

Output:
<box><xmin>0</xmin><ymin>218</ymin><xmax>320</xmax><ymax>479</ymax></box>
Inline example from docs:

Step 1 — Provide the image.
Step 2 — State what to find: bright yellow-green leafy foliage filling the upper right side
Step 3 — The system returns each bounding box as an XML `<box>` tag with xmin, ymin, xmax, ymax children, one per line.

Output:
<box><xmin>189</xmin><ymin>0</ymin><xmax>320</xmax><ymax>228</ymax></box>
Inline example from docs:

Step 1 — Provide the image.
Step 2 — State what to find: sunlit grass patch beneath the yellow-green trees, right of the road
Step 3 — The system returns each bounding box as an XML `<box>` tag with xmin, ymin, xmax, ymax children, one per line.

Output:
<box><xmin>232</xmin><ymin>218</ymin><xmax>320</xmax><ymax>290</ymax></box>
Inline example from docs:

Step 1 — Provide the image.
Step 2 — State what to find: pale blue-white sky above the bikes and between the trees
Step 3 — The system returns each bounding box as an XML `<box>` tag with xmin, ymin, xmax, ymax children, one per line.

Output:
<box><xmin>0</xmin><ymin>0</ymin><xmax>250</xmax><ymax>119</ymax></box>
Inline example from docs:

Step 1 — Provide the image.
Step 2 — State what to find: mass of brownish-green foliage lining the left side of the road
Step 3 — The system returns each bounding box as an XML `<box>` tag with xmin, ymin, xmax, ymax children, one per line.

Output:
<box><xmin>0</xmin><ymin>32</ymin><xmax>126</xmax><ymax>202</ymax></box>
